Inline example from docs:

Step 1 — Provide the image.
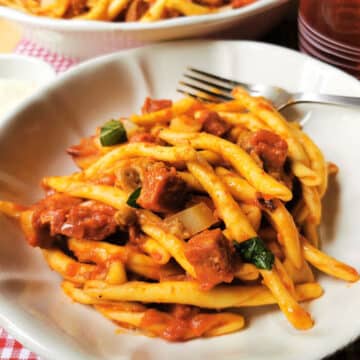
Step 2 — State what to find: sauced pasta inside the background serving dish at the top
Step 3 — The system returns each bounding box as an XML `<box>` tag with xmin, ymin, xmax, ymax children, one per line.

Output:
<box><xmin>0</xmin><ymin>0</ymin><xmax>256</xmax><ymax>22</ymax></box>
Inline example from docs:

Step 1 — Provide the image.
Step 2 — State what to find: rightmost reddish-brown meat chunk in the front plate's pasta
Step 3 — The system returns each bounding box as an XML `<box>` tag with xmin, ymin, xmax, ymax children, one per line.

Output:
<box><xmin>250</xmin><ymin>130</ymin><xmax>288</xmax><ymax>171</ymax></box>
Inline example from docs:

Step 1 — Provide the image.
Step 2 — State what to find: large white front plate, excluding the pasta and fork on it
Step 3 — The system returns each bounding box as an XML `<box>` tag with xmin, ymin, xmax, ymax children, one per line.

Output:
<box><xmin>0</xmin><ymin>42</ymin><xmax>360</xmax><ymax>360</ymax></box>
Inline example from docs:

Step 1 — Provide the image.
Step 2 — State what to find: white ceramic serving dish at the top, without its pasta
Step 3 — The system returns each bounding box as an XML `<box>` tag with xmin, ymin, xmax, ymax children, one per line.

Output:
<box><xmin>0</xmin><ymin>0</ymin><xmax>289</xmax><ymax>59</ymax></box>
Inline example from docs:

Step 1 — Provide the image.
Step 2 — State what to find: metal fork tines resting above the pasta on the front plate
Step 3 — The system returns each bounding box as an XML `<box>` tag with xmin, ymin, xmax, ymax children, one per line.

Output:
<box><xmin>176</xmin><ymin>67</ymin><xmax>239</xmax><ymax>102</ymax></box>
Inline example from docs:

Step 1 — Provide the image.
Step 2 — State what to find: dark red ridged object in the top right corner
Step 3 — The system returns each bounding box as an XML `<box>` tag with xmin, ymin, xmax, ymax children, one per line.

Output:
<box><xmin>298</xmin><ymin>0</ymin><xmax>360</xmax><ymax>79</ymax></box>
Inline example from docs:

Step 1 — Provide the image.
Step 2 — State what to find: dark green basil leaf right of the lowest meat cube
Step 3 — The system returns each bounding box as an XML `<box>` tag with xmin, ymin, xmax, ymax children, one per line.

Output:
<box><xmin>234</xmin><ymin>237</ymin><xmax>274</xmax><ymax>270</ymax></box>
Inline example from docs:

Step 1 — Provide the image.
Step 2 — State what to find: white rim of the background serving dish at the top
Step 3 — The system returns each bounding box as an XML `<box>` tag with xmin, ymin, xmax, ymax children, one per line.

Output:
<box><xmin>0</xmin><ymin>0</ymin><xmax>289</xmax><ymax>32</ymax></box>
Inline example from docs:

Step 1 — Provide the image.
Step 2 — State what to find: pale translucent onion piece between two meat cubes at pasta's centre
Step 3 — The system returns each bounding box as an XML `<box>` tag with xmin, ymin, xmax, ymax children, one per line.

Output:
<box><xmin>164</xmin><ymin>202</ymin><xmax>219</xmax><ymax>239</ymax></box>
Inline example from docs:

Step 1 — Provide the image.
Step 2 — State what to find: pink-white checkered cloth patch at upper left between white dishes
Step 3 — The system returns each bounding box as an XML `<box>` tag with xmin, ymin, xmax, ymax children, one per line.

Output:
<box><xmin>15</xmin><ymin>39</ymin><xmax>78</xmax><ymax>73</ymax></box>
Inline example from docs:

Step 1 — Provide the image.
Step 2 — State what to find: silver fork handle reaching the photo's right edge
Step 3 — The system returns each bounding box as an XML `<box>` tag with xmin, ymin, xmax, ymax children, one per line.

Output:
<box><xmin>279</xmin><ymin>93</ymin><xmax>360</xmax><ymax>110</ymax></box>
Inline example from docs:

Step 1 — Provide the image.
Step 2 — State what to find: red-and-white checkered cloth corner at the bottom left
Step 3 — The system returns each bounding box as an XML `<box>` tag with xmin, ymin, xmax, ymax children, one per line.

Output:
<box><xmin>0</xmin><ymin>328</ymin><xmax>40</xmax><ymax>360</ymax></box>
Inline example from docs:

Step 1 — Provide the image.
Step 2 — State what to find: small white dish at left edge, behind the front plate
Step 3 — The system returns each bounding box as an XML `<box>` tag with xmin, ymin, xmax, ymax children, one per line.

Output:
<box><xmin>0</xmin><ymin>54</ymin><xmax>55</xmax><ymax>119</ymax></box>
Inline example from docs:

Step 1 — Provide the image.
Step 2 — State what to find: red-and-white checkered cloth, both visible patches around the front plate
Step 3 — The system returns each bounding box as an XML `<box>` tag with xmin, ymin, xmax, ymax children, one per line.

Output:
<box><xmin>0</xmin><ymin>39</ymin><xmax>78</xmax><ymax>360</ymax></box>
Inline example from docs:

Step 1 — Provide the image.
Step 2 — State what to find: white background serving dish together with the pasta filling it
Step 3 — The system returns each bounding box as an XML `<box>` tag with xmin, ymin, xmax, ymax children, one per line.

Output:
<box><xmin>0</xmin><ymin>0</ymin><xmax>288</xmax><ymax>59</ymax></box>
